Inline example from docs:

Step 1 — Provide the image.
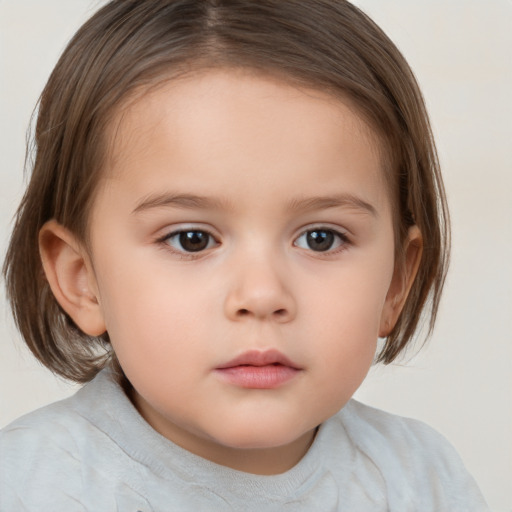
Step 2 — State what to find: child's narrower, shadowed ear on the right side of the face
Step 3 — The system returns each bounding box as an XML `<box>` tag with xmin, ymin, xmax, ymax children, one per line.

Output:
<box><xmin>379</xmin><ymin>226</ymin><xmax>423</xmax><ymax>338</ymax></box>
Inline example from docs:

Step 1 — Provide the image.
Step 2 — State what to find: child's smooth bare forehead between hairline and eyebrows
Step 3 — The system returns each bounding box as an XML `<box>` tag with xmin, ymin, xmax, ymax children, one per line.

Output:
<box><xmin>99</xmin><ymin>69</ymin><xmax>384</xmax><ymax>212</ymax></box>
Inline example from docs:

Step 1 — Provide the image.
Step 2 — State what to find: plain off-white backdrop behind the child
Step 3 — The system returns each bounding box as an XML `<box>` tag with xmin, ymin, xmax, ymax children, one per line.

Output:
<box><xmin>0</xmin><ymin>0</ymin><xmax>512</xmax><ymax>512</ymax></box>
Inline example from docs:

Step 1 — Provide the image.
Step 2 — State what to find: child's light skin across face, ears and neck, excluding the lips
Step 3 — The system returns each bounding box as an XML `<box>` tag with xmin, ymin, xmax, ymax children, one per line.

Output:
<box><xmin>40</xmin><ymin>69</ymin><xmax>421</xmax><ymax>474</ymax></box>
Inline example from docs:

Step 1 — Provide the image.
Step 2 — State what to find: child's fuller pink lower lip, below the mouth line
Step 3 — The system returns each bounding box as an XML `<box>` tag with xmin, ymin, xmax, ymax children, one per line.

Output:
<box><xmin>216</xmin><ymin>364</ymin><xmax>300</xmax><ymax>389</ymax></box>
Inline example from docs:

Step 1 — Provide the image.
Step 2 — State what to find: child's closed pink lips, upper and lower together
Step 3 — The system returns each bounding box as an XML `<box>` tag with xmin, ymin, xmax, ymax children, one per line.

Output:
<box><xmin>215</xmin><ymin>350</ymin><xmax>301</xmax><ymax>389</ymax></box>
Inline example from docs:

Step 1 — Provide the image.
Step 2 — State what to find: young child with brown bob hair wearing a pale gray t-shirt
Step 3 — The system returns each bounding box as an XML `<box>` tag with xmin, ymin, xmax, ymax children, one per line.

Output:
<box><xmin>0</xmin><ymin>0</ymin><xmax>487</xmax><ymax>512</ymax></box>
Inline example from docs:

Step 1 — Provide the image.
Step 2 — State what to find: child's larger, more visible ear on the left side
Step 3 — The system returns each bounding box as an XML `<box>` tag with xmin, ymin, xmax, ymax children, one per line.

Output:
<box><xmin>39</xmin><ymin>220</ymin><xmax>106</xmax><ymax>336</ymax></box>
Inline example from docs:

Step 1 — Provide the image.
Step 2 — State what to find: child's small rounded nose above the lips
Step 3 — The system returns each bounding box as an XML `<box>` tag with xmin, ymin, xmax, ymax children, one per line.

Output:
<box><xmin>225</xmin><ymin>253</ymin><xmax>297</xmax><ymax>323</ymax></box>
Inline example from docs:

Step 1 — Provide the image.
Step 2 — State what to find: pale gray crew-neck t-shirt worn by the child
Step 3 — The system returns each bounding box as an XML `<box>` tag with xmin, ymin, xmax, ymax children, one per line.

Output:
<box><xmin>0</xmin><ymin>370</ymin><xmax>488</xmax><ymax>512</ymax></box>
